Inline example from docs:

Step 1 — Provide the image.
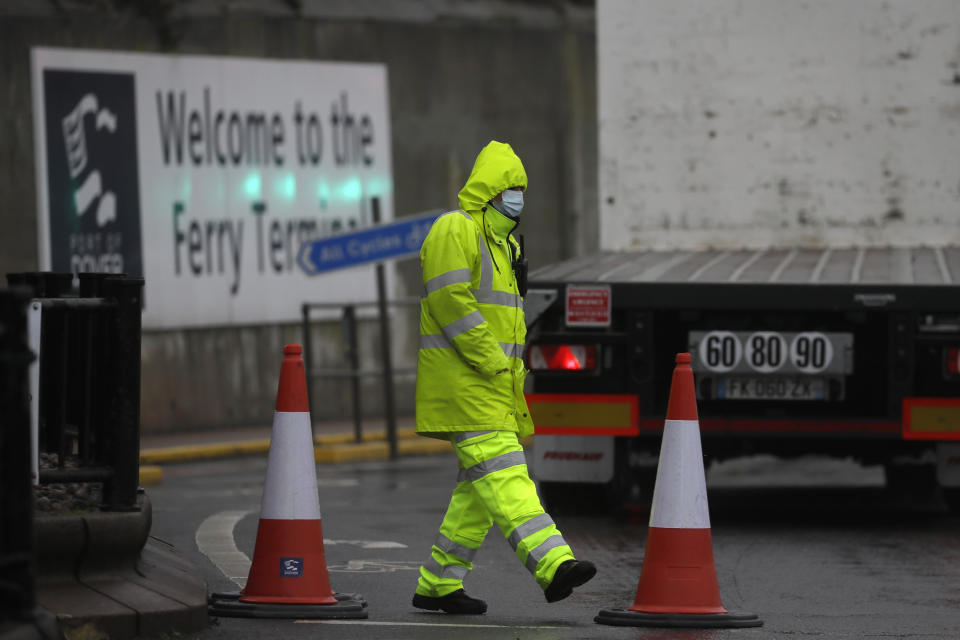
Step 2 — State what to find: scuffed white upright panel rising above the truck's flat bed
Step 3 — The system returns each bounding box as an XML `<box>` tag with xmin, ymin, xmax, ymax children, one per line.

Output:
<box><xmin>597</xmin><ymin>0</ymin><xmax>960</xmax><ymax>249</ymax></box>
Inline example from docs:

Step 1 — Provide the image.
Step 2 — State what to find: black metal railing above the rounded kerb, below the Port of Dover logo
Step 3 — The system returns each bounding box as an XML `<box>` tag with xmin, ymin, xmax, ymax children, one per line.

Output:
<box><xmin>7</xmin><ymin>273</ymin><xmax>143</xmax><ymax>511</ymax></box>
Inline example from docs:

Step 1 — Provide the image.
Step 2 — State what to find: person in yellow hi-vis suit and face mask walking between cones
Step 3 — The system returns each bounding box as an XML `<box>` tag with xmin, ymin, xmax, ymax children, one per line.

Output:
<box><xmin>413</xmin><ymin>141</ymin><xmax>596</xmax><ymax>614</ymax></box>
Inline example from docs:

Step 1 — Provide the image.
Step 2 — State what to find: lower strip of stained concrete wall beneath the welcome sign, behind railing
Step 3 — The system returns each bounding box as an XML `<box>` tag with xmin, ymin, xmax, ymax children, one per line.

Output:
<box><xmin>141</xmin><ymin>307</ymin><xmax>419</xmax><ymax>432</ymax></box>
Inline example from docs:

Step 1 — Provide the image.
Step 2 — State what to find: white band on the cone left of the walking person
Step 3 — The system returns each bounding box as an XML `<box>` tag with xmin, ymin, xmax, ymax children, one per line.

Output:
<box><xmin>260</xmin><ymin>411</ymin><xmax>320</xmax><ymax>520</ymax></box>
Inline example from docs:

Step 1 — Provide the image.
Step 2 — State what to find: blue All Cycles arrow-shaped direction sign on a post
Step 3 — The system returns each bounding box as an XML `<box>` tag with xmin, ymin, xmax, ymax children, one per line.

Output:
<box><xmin>297</xmin><ymin>211</ymin><xmax>442</xmax><ymax>276</ymax></box>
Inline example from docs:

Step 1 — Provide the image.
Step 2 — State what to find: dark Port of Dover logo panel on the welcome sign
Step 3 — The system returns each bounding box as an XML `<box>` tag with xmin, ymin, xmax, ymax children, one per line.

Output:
<box><xmin>43</xmin><ymin>69</ymin><xmax>143</xmax><ymax>276</ymax></box>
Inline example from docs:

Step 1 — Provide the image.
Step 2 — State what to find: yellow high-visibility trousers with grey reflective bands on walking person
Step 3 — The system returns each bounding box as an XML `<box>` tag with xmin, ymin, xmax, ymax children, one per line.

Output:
<box><xmin>417</xmin><ymin>431</ymin><xmax>574</xmax><ymax>598</ymax></box>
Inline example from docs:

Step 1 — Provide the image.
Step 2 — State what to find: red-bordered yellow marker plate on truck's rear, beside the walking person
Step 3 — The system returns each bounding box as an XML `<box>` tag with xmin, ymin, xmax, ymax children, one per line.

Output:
<box><xmin>527</xmin><ymin>393</ymin><xmax>640</xmax><ymax>436</ymax></box>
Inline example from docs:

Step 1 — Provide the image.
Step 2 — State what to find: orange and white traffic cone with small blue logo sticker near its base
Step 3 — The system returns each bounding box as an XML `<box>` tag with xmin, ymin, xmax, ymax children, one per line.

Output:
<box><xmin>210</xmin><ymin>344</ymin><xmax>367</xmax><ymax>618</ymax></box>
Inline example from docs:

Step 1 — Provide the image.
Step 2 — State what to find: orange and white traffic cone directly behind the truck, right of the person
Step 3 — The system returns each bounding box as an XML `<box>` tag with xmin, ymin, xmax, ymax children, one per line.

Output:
<box><xmin>594</xmin><ymin>353</ymin><xmax>763</xmax><ymax>628</ymax></box>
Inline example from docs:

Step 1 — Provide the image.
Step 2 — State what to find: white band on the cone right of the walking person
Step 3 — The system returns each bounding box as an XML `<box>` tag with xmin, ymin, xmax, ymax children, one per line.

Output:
<box><xmin>650</xmin><ymin>420</ymin><xmax>710</xmax><ymax>529</ymax></box>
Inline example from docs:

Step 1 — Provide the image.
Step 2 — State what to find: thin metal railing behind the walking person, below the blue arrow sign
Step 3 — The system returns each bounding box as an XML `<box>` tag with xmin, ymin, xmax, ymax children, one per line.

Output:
<box><xmin>301</xmin><ymin>298</ymin><xmax>420</xmax><ymax>458</ymax></box>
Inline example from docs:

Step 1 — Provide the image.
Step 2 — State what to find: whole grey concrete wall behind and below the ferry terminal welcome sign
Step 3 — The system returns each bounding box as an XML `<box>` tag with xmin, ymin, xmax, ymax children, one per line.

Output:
<box><xmin>0</xmin><ymin>0</ymin><xmax>597</xmax><ymax>432</ymax></box>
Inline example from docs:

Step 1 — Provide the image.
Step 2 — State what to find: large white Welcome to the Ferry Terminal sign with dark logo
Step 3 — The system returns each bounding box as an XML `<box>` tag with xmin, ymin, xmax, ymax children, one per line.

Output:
<box><xmin>33</xmin><ymin>48</ymin><xmax>393</xmax><ymax>328</ymax></box>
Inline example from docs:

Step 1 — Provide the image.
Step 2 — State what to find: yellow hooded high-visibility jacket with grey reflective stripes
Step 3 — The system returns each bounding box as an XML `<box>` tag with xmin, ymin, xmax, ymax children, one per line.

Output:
<box><xmin>417</xmin><ymin>141</ymin><xmax>533</xmax><ymax>437</ymax></box>
